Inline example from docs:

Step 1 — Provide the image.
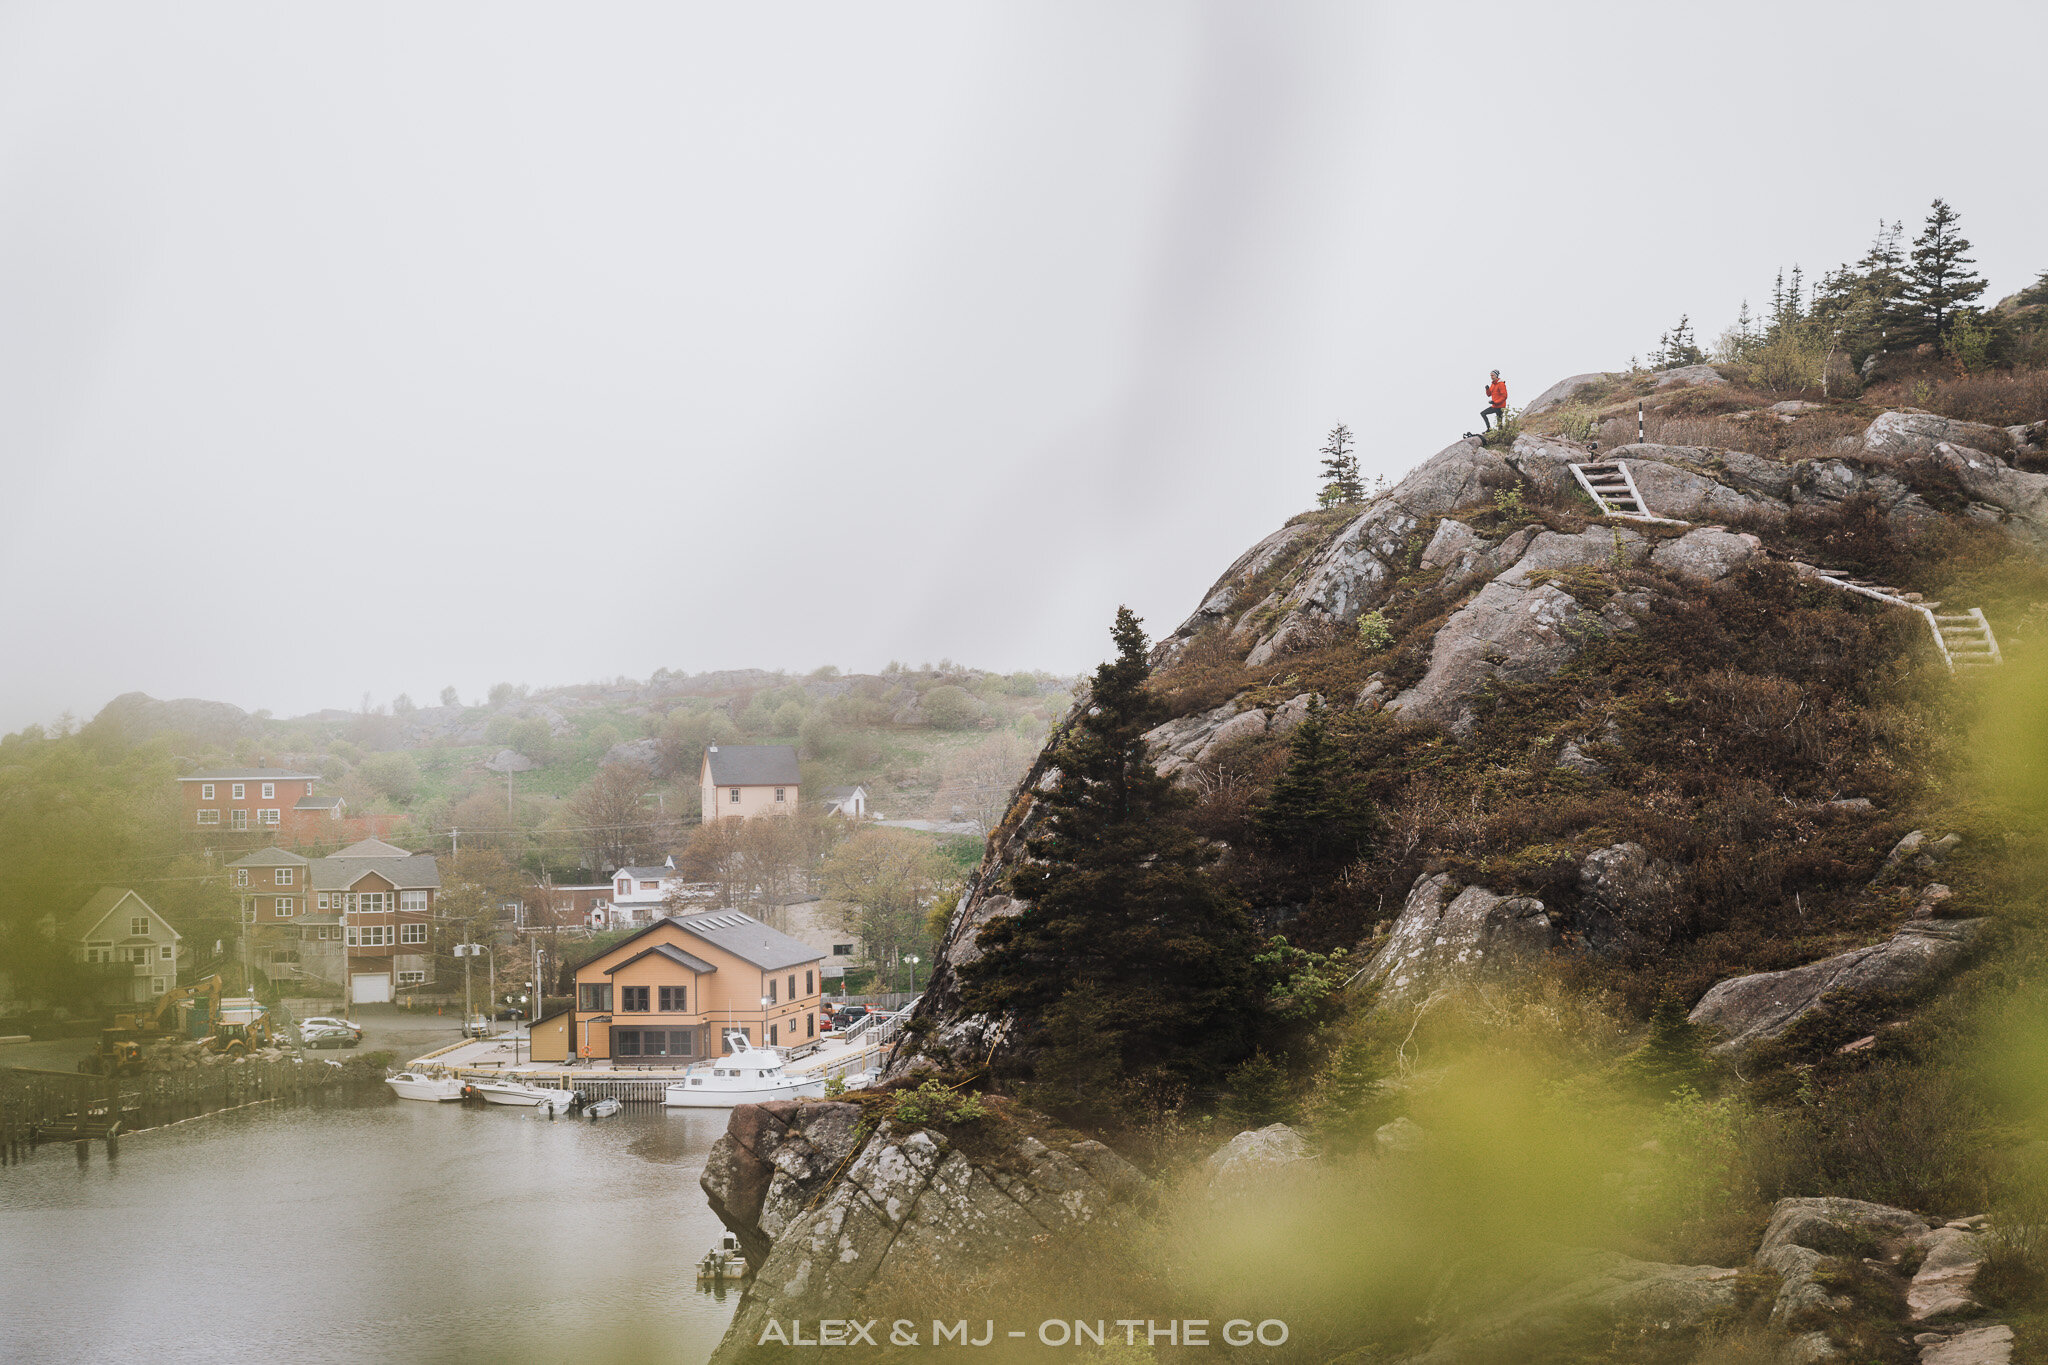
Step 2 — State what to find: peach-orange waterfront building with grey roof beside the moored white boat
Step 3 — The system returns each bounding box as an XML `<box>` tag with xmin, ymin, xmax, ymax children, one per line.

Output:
<box><xmin>571</xmin><ymin>911</ymin><xmax>823</xmax><ymax>1066</ymax></box>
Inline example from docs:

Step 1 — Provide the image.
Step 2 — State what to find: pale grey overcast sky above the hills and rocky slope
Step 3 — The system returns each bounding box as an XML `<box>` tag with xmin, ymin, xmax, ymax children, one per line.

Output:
<box><xmin>0</xmin><ymin>0</ymin><xmax>2048</xmax><ymax>731</ymax></box>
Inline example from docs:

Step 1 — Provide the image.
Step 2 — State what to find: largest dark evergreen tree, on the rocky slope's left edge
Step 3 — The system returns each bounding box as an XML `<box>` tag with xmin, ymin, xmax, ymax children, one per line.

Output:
<box><xmin>961</xmin><ymin>608</ymin><xmax>1260</xmax><ymax>1085</ymax></box>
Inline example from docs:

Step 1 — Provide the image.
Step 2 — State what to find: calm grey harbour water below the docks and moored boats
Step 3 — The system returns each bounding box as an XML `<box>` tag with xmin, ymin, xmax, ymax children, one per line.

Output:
<box><xmin>0</xmin><ymin>1097</ymin><xmax>737</xmax><ymax>1365</ymax></box>
